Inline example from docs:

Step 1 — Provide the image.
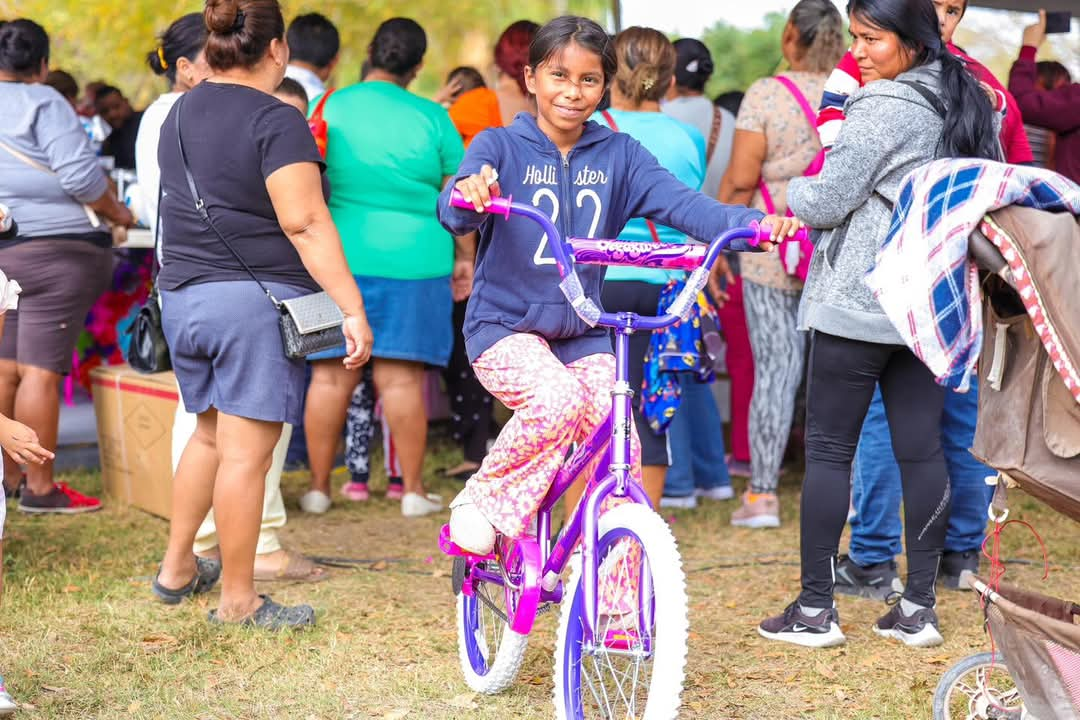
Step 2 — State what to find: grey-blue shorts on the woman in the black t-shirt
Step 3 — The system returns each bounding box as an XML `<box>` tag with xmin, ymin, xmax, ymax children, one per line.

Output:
<box><xmin>161</xmin><ymin>281</ymin><xmax>311</xmax><ymax>424</ymax></box>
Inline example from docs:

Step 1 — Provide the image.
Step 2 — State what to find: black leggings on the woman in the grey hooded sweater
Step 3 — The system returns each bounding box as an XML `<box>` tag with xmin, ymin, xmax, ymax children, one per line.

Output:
<box><xmin>799</xmin><ymin>331</ymin><xmax>949</xmax><ymax>608</ymax></box>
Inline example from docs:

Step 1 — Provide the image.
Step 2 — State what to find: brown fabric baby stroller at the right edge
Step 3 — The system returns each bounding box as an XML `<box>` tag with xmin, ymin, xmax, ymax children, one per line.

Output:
<box><xmin>933</xmin><ymin>206</ymin><xmax>1080</xmax><ymax>720</ymax></box>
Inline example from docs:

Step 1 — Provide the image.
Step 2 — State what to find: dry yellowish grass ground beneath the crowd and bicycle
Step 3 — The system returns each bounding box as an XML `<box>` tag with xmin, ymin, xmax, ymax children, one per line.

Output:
<box><xmin>0</xmin><ymin>433</ymin><xmax>1080</xmax><ymax>720</ymax></box>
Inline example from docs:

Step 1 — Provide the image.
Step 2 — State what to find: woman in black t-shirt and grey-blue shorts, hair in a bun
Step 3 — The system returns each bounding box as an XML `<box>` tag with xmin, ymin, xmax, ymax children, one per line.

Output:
<box><xmin>153</xmin><ymin>0</ymin><xmax>373</xmax><ymax>629</ymax></box>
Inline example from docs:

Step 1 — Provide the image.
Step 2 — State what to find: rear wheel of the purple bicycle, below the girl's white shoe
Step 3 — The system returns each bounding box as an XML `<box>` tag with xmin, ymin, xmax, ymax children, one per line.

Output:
<box><xmin>457</xmin><ymin>558</ymin><xmax>529</xmax><ymax>695</ymax></box>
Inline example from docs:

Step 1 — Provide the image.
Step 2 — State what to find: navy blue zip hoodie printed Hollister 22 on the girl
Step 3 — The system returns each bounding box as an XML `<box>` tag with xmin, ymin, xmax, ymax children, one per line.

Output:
<box><xmin>437</xmin><ymin>112</ymin><xmax>764</xmax><ymax>371</ymax></box>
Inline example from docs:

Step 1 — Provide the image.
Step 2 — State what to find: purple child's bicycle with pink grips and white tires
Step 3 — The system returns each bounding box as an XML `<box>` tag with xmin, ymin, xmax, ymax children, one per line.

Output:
<box><xmin>438</xmin><ymin>192</ymin><xmax>805</xmax><ymax>720</ymax></box>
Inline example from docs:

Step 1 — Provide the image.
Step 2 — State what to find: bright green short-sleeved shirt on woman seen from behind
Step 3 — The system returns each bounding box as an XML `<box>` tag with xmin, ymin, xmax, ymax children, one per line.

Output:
<box><xmin>312</xmin><ymin>81</ymin><xmax>464</xmax><ymax>280</ymax></box>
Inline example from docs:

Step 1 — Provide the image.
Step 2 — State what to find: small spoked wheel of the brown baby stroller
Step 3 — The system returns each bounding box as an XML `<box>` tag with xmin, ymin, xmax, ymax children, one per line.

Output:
<box><xmin>933</xmin><ymin>652</ymin><xmax>1028</xmax><ymax>720</ymax></box>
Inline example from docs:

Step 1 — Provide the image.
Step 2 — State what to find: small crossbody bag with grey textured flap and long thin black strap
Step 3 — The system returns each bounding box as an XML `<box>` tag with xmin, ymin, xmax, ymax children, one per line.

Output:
<box><xmin>176</xmin><ymin>97</ymin><xmax>345</xmax><ymax>359</ymax></box>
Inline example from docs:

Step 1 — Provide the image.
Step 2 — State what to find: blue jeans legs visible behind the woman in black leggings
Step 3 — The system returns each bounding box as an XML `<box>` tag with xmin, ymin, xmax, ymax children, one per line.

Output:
<box><xmin>850</xmin><ymin>386</ymin><xmax>995</xmax><ymax>566</ymax></box>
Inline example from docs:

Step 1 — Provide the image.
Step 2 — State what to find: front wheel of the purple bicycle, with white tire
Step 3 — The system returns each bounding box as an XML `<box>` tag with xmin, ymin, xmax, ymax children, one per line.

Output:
<box><xmin>554</xmin><ymin>503</ymin><xmax>689</xmax><ymax>720</ymax></box>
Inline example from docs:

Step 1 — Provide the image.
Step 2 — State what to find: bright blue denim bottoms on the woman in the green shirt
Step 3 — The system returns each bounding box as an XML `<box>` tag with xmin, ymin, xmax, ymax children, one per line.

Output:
<box><xmin>308</xmin><ymin>275</ymin><xmax>454</xmax><ymax>367</ymax></box>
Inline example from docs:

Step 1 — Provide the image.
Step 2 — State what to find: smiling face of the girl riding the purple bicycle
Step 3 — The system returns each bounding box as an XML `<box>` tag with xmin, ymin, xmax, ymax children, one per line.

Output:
<box><xmin>525</xmin><ymin>42</ymin><xmax>605</xmax><ymax>152</ymax></box>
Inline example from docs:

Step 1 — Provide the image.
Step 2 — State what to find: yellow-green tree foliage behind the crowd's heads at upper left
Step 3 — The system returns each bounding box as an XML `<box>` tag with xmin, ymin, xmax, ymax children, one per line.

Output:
<box><xmin>8</xmin><ymin>0</ymin><xmax>610</xmax><ymax>107</ymax></box>
